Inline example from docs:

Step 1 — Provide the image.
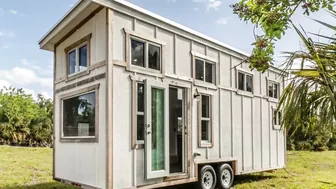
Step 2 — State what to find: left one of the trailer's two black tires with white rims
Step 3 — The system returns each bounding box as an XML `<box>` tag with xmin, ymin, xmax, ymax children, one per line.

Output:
<box><xmin>197</xmin><ymin>165</ymin><xmax>217</xmax><ymax>189</ymax></box>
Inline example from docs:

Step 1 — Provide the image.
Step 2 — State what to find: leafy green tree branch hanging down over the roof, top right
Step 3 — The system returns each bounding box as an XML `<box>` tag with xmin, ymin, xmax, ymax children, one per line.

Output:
<box><xmin>231</xmin><ymin>0</ymin><xmax>335</xmax><ymax>72</ymax></box>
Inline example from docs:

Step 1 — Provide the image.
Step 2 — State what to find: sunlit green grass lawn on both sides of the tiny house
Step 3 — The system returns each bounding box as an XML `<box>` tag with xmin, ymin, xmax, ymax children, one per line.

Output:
<box><xmin>0</xmin><ymin>146</ymin><xmax>336</xmax><ymax>189</ymax></box>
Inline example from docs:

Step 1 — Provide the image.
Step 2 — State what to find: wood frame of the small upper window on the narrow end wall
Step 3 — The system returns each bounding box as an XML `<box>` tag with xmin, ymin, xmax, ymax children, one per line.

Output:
<box><xmin>64</xmin><ymin>34</ymin><xmax>92</xmax><ymax>80</ymax></box>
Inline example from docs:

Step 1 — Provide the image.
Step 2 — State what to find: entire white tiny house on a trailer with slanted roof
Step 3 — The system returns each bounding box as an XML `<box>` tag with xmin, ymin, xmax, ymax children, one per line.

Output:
<box><xmin>39</xmin><ymin>0</ymin><xmax>286</xmax><ymax>189</ymax></box>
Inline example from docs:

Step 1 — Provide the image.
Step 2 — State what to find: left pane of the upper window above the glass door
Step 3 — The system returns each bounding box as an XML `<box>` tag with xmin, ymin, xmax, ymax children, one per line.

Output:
<box><xmin>131</xmin><ymin>39</ymin><xmax>145</xmax><ymax>67</ymax></box>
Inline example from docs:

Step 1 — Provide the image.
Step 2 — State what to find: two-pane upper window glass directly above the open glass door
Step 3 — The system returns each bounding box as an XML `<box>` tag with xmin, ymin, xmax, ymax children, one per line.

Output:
<box><xmin>131</xmin><ymin>38</ymin><xmax>161</xmax><ymax>71</ymax></box>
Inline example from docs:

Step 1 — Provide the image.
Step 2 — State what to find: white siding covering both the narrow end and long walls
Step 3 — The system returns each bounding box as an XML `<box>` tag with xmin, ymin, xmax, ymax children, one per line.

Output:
<box><xmin>46</xmin><ymin>0</ymin><xmax>285</xmax><ymax>189</ymax></box>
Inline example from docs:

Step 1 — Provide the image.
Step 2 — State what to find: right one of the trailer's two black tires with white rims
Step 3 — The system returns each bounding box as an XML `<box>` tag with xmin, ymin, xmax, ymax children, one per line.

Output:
<box><xmin>216</xmin><ymin>164</ymin><xmax>234</xmax><ymax>189</ymax></box>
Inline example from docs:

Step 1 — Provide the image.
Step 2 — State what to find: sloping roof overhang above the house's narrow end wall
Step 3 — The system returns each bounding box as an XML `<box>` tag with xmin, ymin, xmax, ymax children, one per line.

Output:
<box><xmin>39</xmin><ymin>0</ymin><xmax>101</xmax><ymax>51</ymax></box>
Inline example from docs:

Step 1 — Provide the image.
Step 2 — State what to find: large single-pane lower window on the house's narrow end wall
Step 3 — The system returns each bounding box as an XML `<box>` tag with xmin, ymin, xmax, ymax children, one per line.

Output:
<box><xmin>62</xmin><ymin>92</ymin><xmax>96</xmax><ymax>138</ymax></box>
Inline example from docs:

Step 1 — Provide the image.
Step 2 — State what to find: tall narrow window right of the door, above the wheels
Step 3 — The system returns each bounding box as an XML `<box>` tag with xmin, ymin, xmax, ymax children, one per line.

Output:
<box><xmin>199</xmin><ymin>95</ymin><xmax>212</xmax><ymax>147</ymax></box>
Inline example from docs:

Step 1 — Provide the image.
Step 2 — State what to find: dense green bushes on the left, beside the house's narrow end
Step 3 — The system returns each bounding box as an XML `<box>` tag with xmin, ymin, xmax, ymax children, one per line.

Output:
<box><xmin>0</xmin><ymin>87</ymin><xmax>53</xmax><ymax>146</ymax></box>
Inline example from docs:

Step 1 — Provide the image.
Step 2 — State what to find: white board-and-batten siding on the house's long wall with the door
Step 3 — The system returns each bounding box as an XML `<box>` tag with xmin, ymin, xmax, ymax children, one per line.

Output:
<box><xmin>105</xmin><ymin>1</ymin><xmax>285</xmax><ymax>188</ymax></box>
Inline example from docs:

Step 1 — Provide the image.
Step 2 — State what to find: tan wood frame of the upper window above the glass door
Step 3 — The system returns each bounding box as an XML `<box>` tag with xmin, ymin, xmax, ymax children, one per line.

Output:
<box><xmin>124</xmin><ymin>28</ymin><xmax>167</xmax><ymax>78</ymax></box>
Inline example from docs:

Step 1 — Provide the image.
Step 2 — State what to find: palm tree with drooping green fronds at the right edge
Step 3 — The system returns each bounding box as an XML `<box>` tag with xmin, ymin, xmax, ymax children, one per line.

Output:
<box><xmin>278</xmin><ymin>11</ymin><xmax>336</xmax><ymax>136</ymax></box>
